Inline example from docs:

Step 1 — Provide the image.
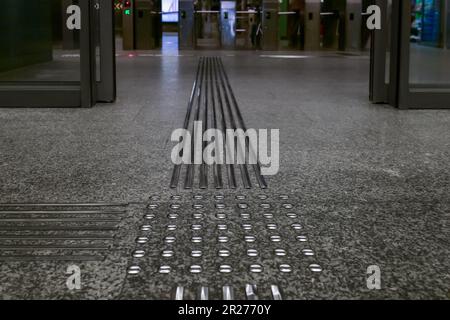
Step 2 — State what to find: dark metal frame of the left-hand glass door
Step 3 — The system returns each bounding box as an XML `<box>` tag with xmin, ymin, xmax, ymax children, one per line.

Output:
<box><xmin>0</xmin><ymin>0</ymin><xmax>116</xmax><ymax>108</ymax></box>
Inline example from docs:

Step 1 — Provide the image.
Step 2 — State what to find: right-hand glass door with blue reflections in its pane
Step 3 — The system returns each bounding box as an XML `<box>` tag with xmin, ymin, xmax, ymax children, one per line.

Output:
<box><xmin>398</xmin><ymin>0</ymin><xmax>450</xmax><ymax>108</ymax></box>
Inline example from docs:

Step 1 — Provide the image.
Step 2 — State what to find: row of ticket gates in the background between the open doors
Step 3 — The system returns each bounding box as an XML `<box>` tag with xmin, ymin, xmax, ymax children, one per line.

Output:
<box><xmin>111</xmin><ymin>0</ymin><xmax>371</xmax><ymax>51</ymax></box>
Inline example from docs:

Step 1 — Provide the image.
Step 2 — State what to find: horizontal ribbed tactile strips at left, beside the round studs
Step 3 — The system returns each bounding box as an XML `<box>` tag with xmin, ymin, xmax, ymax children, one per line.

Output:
<box><xmin>0</xmin><ymin>203</ymin><xmax>126</xmax><ymax>262</ymax></box>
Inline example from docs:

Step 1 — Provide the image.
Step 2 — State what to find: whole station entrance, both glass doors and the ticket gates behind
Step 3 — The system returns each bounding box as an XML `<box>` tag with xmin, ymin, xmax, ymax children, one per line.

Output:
<box><xmin>0</xmin><ymin>0</ymin><xmax>450</xmax><ymax>108</ymax></box>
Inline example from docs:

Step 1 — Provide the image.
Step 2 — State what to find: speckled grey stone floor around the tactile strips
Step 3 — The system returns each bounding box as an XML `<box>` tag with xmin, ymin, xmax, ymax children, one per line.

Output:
<box><xmin>0</xmin><ymin>52</ymin><xmax>450</xmax><ymax>299</ymax></box>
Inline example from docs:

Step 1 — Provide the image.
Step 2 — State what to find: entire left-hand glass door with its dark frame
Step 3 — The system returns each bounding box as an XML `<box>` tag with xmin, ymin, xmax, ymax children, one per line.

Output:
<box><xmin>0</xmin><ymin>0</ymin><xmax>115</xmax><ymax>107</ymax></box>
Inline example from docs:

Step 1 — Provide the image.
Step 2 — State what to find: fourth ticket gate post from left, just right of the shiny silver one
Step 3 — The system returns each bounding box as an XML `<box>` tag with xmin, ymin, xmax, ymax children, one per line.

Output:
<box><xmin>261</xmin><ymin>0</ymin><xmax>279</xmax><ymax>50</ymax></box>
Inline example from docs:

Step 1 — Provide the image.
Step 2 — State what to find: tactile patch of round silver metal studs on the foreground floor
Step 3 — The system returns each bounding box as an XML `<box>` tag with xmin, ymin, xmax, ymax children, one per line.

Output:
<box><xmin>122</xmin><ymin>193</ymin><xmax>322</xmax><ymax>300</ymax></box>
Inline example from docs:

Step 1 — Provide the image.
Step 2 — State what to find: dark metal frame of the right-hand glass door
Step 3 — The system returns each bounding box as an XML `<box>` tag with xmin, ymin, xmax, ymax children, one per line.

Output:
<box><xmin>370</xmin><ymin>0</ymin><xmax>450</xmax><ymax>109</ymax></box>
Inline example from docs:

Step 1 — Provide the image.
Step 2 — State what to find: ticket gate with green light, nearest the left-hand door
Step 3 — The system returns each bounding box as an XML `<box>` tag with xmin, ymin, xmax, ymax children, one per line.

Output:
<box><xmin>122</xmin><ymin>0</ymin><xmax>162</xmax><ymax>50</ymax></box>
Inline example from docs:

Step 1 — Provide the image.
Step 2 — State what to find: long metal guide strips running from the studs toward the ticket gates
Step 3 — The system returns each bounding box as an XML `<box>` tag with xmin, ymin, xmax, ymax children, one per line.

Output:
<box><xmin>170</xmin><ymin>57</ymin><xmax>267</xmax><ymax>189</ymax></box>
